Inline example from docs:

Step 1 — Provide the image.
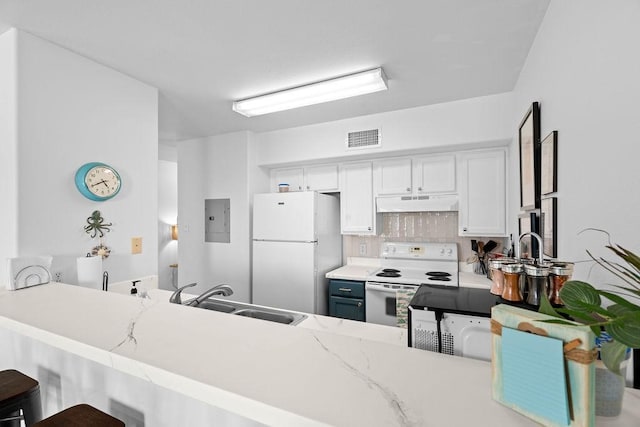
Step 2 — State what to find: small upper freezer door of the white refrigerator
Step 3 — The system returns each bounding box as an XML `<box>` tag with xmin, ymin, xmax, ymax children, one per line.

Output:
<box><xmin>253</xmin><ymin>191</ymin><xmax>317</xmax><ymax>242</ymax></box>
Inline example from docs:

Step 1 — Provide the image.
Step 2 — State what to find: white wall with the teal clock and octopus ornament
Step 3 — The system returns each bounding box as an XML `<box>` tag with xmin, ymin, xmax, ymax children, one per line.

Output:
<box><xmin>0</xmin><ymin>31</ymin><xmax>158</xmax><ymax>283</ymax></box>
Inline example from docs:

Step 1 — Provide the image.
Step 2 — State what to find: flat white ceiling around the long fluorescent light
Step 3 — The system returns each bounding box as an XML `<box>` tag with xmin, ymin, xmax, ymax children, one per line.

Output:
<box><xmin>0</xmin><ymin>0</ymin><xmax>550</xmax><ymax>142</ymax></box>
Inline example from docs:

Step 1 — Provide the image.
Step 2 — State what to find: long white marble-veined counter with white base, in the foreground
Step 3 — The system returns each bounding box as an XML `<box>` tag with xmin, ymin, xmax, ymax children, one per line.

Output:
<box><xmin>0</xmin><ymin>283</ymin><xmax>640</xmax><ymax>426</ymax></box>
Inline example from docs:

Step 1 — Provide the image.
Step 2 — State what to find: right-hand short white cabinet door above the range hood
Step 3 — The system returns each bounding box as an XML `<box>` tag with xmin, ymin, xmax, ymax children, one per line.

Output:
<box><xmin>413</xmin><ymin>154</ymin><xmax>456</xmax><ymax>194</ymax></box>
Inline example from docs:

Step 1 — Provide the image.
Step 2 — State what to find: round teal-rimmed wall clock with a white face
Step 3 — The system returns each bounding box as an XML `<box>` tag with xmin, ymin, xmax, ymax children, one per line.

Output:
<box><xmin>76</xmin><ymin>162</ymin><xmax>122</xmax><ymax>202</ymax></box>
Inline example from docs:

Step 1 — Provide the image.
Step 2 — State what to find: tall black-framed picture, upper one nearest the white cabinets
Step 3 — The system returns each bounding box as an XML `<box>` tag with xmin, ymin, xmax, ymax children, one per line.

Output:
<box><xmin>518</xmin><ymin>102</ymin><xmax>540</xmax><ymax>211</ymax></box>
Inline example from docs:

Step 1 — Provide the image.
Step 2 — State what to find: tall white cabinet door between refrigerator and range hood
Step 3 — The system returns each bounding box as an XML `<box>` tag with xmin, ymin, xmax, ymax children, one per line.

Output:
<box><xmin>340</xmin><ymin>162</ymin><xmax>376</xmax><ymax>235</ymax></box>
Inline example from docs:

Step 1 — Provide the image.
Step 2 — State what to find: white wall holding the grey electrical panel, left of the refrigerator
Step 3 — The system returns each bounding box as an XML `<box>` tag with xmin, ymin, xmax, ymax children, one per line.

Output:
<box><xmin>178</xmin><ymin>132</ymin><xmax>251</xmax><ymax>302</ymax></box>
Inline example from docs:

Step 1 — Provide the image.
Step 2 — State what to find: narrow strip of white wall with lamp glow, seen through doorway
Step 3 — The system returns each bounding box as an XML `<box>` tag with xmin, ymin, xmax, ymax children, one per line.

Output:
<box><xmin>158</xmin><ymin>160</ymin><xmax>178</xmax><ymax>289</ymax></box>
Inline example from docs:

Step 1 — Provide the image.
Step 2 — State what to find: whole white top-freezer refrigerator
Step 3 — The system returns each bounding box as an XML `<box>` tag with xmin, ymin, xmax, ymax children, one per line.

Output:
<box><xmin>252</xmin><ymin>191</ymin><xmax>342</xmax><ymax>314</ymax></box>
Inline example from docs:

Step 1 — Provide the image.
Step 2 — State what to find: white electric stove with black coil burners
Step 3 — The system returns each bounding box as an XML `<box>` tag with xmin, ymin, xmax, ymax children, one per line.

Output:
<box><xmin>365</xmin><ymin>242</ymin><xmax>458</xmax><ymax>326</ymax></box>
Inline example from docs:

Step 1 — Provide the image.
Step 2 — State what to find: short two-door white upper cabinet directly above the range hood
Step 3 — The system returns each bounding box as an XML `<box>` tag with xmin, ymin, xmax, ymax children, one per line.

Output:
<box><xmin>373</xmin><ymin>154</ymin><xmax>456</xmax><ymax>195</ymax></box>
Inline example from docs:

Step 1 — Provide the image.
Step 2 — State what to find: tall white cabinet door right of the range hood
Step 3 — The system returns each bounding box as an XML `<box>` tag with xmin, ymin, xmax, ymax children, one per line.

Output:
<box><xmin>458</xmin><ymin>149</ymin><xmax>506</xmax><ymax>236</ymax></box>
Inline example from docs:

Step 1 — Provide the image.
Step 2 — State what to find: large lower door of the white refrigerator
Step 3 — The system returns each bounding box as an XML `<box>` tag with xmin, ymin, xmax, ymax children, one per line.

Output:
<box><xmin>252</xmin><ymin>241</ymin><xmax>318</xmax><ymax>313</ymax></box>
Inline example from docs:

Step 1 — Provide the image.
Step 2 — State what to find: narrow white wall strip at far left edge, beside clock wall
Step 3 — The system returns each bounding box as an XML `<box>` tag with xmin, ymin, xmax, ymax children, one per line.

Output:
<box><xmin>0</xmin><ymin>30</ymin><xmax>18</xmax><ymax>284</ymax></box>
